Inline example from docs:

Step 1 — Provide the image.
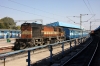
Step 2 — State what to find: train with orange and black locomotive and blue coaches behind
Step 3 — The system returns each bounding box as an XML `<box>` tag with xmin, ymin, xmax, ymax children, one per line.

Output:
<box><xmin>14</xmin><ymin>22</ymin><xmax>88</xmax><ymax>50</ymax></box>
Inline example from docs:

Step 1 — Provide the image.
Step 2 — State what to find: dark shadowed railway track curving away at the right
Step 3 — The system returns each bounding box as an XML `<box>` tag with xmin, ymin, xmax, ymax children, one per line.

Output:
<box><xmin>60</xmin><ymin>37</ymin><xmax>100</xmax><ymax>66</ymax></box>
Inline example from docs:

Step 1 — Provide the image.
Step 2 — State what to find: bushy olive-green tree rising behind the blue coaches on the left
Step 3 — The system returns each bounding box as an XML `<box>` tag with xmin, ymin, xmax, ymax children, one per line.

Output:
<box><xmin>1</xmin><ymin>17</ymin><xmax>16</xmax><ymax>29</ymax></box>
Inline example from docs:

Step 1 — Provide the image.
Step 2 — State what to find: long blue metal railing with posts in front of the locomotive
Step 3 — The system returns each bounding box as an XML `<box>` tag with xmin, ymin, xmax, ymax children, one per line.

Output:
<box><xmin>0</xmin><ymin>37</ymin><xmax>88</xmax><ymax>66</ymax></box>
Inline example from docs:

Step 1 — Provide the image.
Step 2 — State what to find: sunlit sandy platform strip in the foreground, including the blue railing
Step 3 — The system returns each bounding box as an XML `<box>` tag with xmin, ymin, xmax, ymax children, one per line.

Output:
<box><xmin>0</xmin><ymin>36</ymin><xmax>86</xmax><ymax>66</ymax></box>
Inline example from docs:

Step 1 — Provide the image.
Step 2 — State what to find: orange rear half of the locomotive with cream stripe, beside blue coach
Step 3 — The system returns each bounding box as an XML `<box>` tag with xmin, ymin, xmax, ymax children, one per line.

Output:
<box><xmin>42</xmin><ymin>26</ymin><xmax>65</xmax><ymax>44</ymax></box>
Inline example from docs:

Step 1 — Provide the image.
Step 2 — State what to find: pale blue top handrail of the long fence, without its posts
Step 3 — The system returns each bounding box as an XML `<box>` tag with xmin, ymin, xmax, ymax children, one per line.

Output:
<box><xmin>0</xmin><ymin>37</ymin><xmax>88</xmax><ymax>66</ymax></box>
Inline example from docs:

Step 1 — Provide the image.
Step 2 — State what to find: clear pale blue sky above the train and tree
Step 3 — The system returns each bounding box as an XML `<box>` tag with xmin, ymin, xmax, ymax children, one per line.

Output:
<box><xmin>0</xmin><ymin>0</ymin><xmax>100</xmax><ymax>30</ymax></box>
